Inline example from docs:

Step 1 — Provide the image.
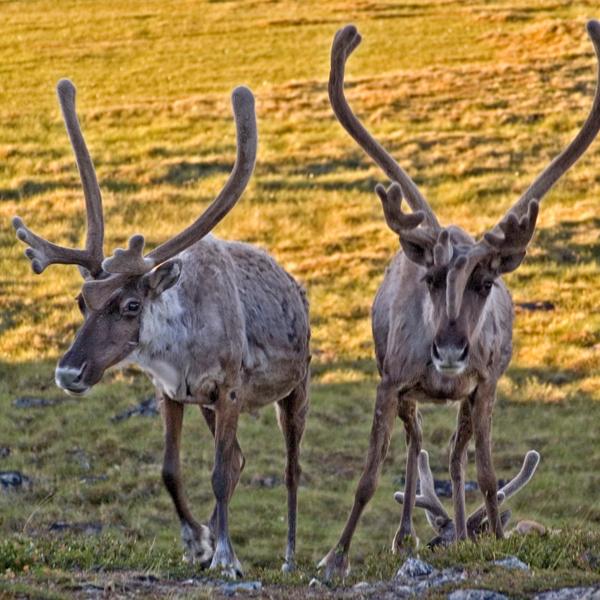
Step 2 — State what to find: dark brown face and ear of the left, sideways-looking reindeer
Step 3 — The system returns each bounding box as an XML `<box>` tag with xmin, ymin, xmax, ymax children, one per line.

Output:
<box><xmin>55</xmin><ymin>260</ymin><xmax>181</xmax><ymax>395</ymax></box>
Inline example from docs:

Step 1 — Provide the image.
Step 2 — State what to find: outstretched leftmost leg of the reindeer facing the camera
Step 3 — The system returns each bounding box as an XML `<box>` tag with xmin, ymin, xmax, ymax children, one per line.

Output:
<box><xmin>318</xmin><ymin>380</ymin><xmax>398</xmax><ymax>581</ymax></box>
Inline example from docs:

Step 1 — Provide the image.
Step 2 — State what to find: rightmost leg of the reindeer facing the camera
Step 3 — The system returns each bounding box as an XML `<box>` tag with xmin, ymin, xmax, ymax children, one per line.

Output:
<box><xmin>471</xmin><ymin>381</ymin><xmax>504</xmax><ymax>538</ymax></box>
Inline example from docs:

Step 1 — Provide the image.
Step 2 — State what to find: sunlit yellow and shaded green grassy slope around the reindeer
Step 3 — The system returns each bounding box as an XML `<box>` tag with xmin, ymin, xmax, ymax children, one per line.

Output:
<box><xmin>0</xmin><ymin>0</ymin><xmax>600</xmax><ymax>597</ymax></box>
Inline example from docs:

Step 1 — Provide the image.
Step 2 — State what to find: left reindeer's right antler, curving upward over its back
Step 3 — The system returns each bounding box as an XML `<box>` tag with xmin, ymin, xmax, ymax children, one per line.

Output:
<box><xmin>103</xmin><ymin>86</ymin><xmax>258</xmax><ymax>275</ymax></box>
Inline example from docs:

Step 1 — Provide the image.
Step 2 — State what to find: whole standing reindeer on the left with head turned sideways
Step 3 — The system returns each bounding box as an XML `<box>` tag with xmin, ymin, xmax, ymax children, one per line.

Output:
<box><xmin>13</xmin><ymin>80</ymin><xmax>310</xmax><ymax>576</ymax></box>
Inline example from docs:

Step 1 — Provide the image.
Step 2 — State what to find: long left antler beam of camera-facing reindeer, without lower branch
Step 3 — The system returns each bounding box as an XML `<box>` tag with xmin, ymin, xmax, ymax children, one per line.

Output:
<box><xmin>329</xmin><ymin>25</ymin><xmax>440</xmax><ymax>231</ymax></box>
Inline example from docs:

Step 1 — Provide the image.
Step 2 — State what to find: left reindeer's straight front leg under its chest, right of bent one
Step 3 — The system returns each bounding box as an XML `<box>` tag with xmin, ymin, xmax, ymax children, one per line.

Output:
<box><xmin>210</xmin><ymin>389</ymin><xmax>243</xmax><ymax>578</ymax></box>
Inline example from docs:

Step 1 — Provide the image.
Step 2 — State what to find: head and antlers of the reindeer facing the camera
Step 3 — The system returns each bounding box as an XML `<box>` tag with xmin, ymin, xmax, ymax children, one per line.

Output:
<box><xmin>329</xmin><ymin>21</ymin><xmax>600</xmax><ymax>375</ymax></box>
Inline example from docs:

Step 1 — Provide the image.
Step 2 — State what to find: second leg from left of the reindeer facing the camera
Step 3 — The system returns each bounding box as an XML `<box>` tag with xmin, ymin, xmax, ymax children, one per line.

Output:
<box><xmin>392</xmin><ymin>398</ymin><xmax>422</xmax><ymax>552</ymax></box>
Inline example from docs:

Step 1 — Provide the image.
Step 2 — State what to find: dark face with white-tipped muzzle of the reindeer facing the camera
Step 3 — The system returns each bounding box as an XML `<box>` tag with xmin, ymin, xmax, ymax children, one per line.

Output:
<box><xmin>424</xmin><ymin>263</ymin><xmax>498</xmax><ymax>375</ymax></box>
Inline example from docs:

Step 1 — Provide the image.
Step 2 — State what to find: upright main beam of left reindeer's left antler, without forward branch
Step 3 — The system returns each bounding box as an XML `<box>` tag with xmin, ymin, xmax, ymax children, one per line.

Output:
<box><xmin>56</xmin><ymin>79</ymin><xmax>104</xmax><ymax>275</ymax></box>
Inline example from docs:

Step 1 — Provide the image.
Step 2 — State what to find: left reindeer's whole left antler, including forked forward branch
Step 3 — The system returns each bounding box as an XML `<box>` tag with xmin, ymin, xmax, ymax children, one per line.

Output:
<box><xmin>12</xmin><ymin>79</ymin><xmax>104</xmax><ymax>277</ymax></box>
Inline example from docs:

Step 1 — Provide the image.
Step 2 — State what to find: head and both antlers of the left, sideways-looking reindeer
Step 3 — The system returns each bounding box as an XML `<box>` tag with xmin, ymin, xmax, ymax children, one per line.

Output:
<box><xmin>13</xmin><ymin>80</ymin><xmax>257</xmax><ymax>394</ymax></box>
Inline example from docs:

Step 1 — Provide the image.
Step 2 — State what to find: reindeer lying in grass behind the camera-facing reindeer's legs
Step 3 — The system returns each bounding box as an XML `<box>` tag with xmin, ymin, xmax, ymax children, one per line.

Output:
<box><xmin>394</xmin><ymin>450</ymin><xmax>540</xmax><ymax>547</ymax></box>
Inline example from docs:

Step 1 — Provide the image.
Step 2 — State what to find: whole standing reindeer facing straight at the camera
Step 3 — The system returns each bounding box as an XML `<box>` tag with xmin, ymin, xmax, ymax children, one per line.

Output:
<box><xmin>319</xmin><ymin>21</ymin><xmax>600</xmax><ymax>579</ymax></box>
